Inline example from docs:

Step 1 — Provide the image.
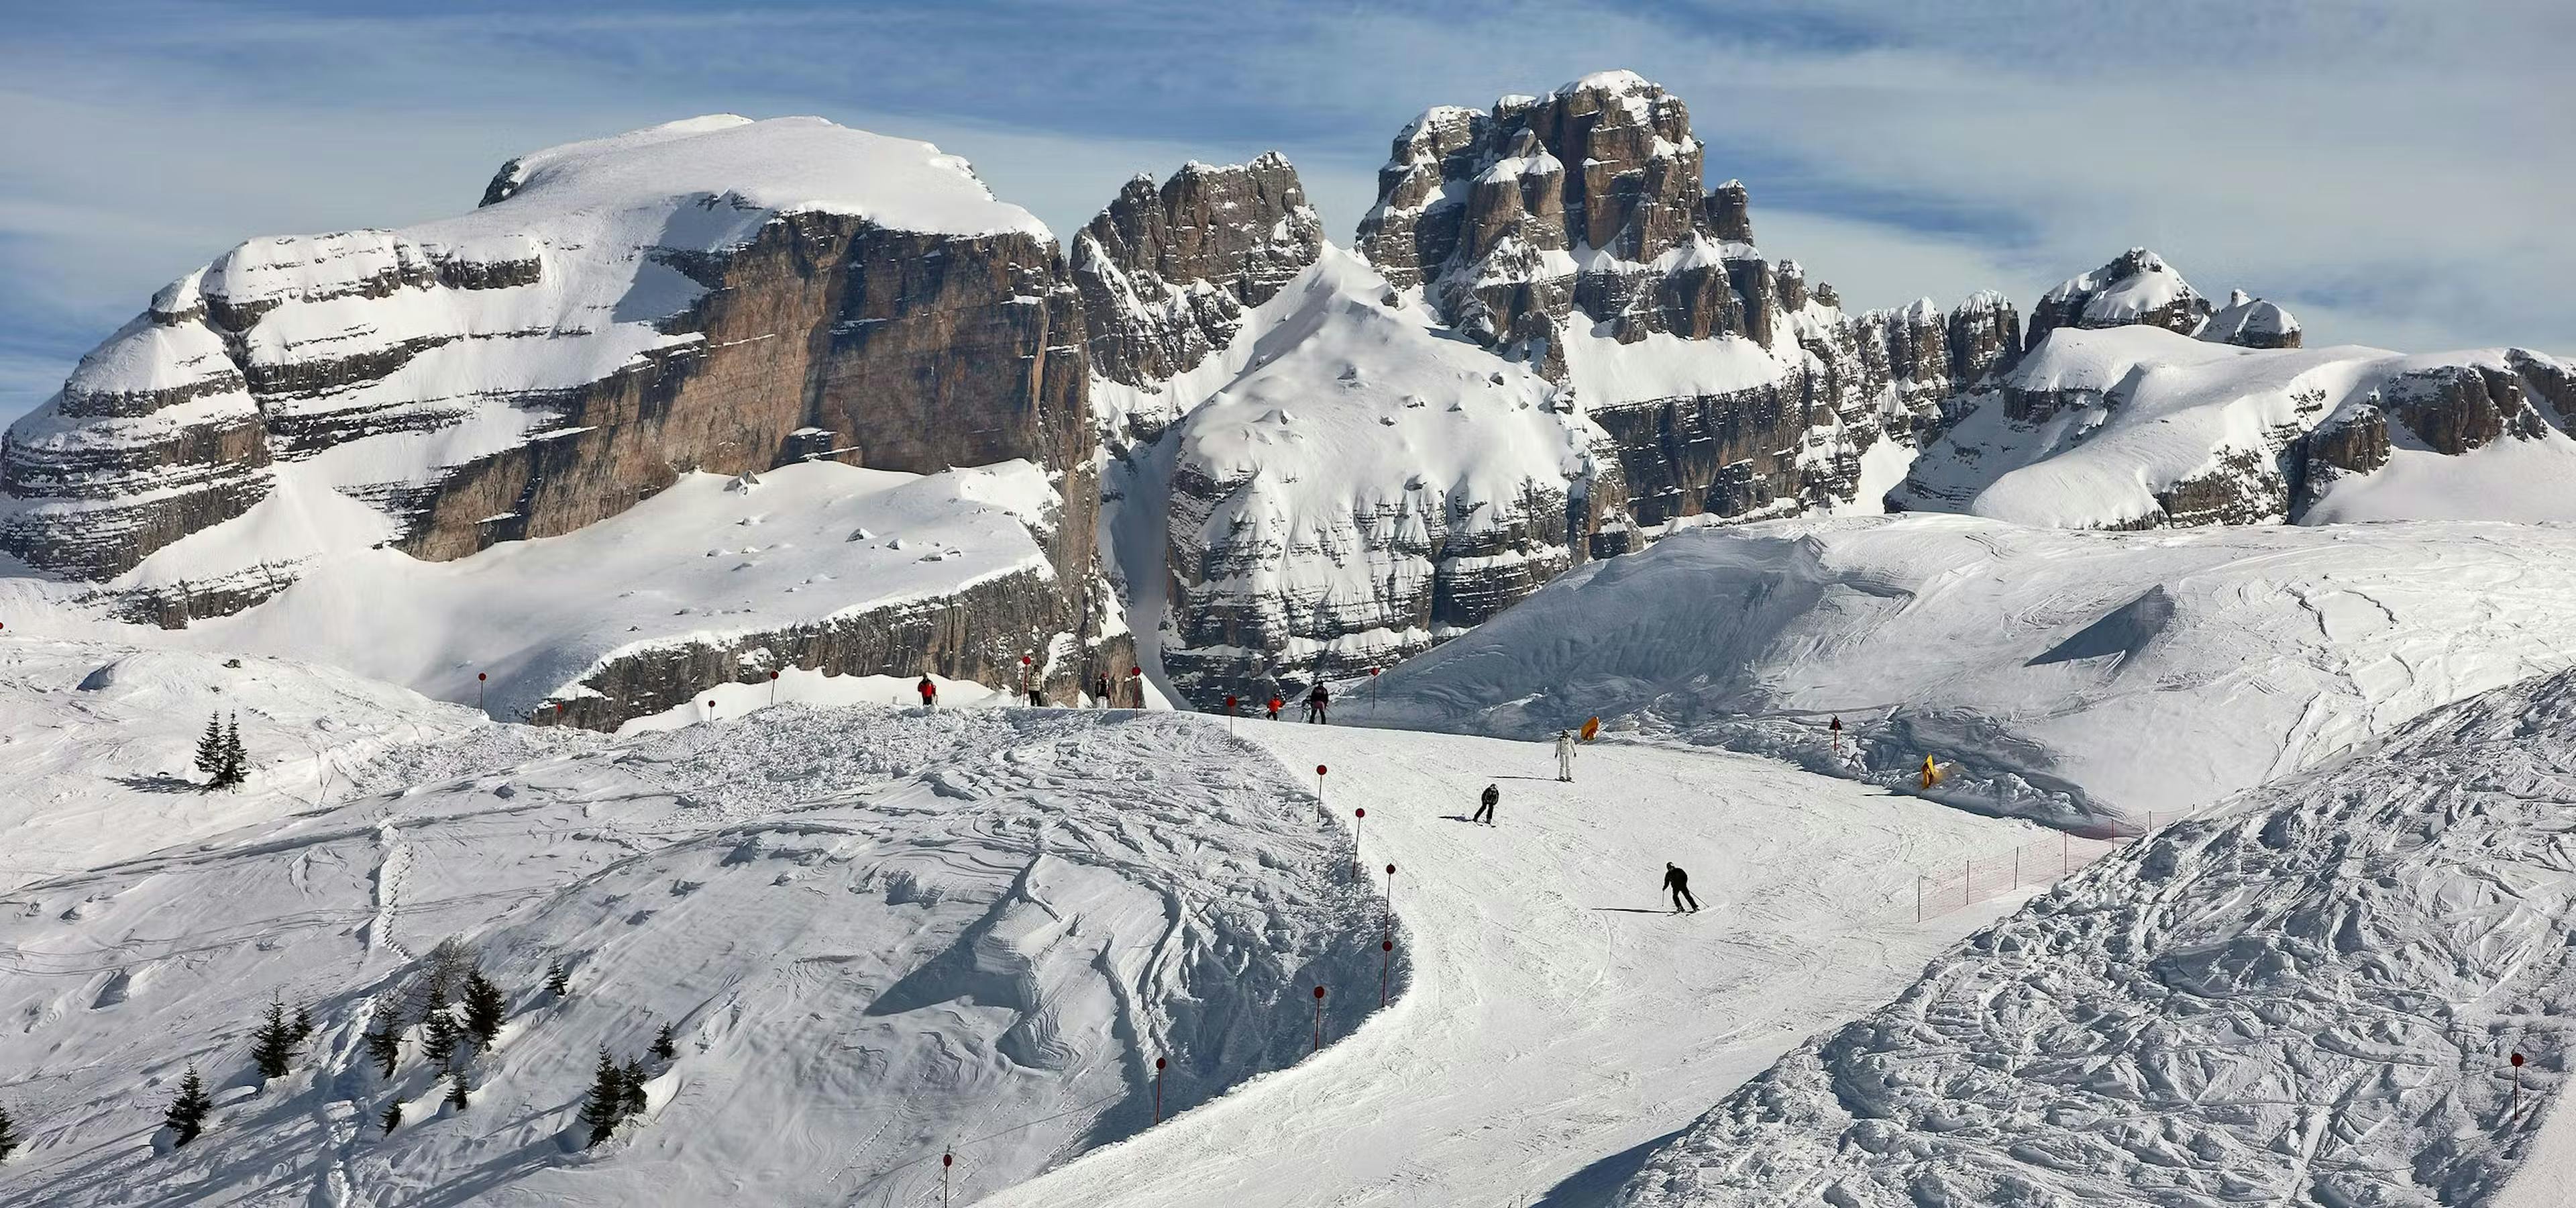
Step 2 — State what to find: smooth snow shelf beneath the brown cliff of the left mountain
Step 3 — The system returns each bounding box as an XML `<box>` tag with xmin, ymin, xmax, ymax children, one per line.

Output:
<box><xmin>0</xmin><ymin>461</ymin><xmax>1056</xmax><ymax>719</ymax></box>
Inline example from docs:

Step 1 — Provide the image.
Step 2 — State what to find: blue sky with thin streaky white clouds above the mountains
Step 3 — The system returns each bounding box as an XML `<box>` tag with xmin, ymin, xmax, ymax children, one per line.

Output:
<box><xmin>0</xmin><ymin>0</ymin><xmax>2576</xmax><ymax>417</ymax></box>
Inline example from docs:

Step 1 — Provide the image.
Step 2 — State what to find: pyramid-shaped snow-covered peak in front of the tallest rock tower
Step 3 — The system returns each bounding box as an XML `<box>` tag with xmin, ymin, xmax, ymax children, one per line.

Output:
<box><xmin>1162</xmin><ymin>247</ymin><xmax>1600</xmax><ymax>698</ymax></box>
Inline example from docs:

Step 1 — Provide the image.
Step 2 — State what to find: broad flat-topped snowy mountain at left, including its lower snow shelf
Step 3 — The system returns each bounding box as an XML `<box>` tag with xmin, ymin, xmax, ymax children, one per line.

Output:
<box><xmin>0</xmin><ymin>119</ymin><xmax>1126</xmax><ymax>726</ymax></box>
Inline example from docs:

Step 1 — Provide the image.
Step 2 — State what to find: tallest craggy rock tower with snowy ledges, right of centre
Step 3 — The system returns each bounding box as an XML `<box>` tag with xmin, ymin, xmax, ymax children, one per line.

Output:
<box><xmin>1360</xmin><ymin>72</ymin><xmax>2022</xmax><ymax>538</ymax></box>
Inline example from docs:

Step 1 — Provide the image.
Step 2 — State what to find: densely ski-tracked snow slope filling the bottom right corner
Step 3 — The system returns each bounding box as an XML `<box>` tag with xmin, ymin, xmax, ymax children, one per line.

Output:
<box><xmin>1618</xmin><ymin>672</ymin><xmax>2576</xmax><ymax>1208</ymax></box>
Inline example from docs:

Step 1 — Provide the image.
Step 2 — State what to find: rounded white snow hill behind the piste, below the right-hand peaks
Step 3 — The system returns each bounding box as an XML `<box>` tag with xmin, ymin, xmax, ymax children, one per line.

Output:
<box><xmin>1381</xmin><ymin>515</ymin><xmax>2576</xmax><ymax>827</ymax></box>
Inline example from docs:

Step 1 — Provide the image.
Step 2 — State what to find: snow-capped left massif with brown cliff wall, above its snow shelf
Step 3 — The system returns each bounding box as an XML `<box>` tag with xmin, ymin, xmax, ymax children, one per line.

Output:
<box><xmin>0</xmin><ymin>119</ymin><xmax>1118</xmax><ymax>715</ymax></box>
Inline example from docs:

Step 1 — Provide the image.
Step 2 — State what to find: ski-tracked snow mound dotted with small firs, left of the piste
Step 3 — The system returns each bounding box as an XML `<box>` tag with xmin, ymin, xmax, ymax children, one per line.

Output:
<box><xmin>0</xmin><ymin>708</ymin><xmax>1370</xmax><ymax>1205</ymax></box>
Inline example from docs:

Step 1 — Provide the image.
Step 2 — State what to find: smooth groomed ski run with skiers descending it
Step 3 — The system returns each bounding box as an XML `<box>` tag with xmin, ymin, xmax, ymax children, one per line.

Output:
<box><xmin>976</xmin><ymin>721</ymin><xmax>2037</xmax><ymax>1208</ymax></box>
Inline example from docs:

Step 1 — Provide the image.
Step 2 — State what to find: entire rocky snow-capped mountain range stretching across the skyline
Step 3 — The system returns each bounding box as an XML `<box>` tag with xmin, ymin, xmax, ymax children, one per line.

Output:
<box><xmin>0</xmin><ymin>82</ymin><xmax>2576</xmax><ymax>723</ymax></box>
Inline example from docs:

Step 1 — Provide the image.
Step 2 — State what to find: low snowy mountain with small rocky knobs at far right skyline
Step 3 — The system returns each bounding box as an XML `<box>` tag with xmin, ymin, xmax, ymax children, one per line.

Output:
<box><xmin>1886</xmin><ymin>247</ymin><xmax>2576</xmax><ymax>528</ymax></box>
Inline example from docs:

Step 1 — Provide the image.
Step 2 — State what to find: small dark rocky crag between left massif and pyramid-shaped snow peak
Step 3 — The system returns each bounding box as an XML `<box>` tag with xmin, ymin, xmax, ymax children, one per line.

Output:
<box><xmin>1071</xmin><ymin>152</ymin><xmax>1324</xmax><ymax>438</ymax></box>
